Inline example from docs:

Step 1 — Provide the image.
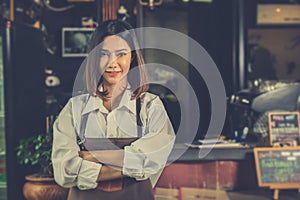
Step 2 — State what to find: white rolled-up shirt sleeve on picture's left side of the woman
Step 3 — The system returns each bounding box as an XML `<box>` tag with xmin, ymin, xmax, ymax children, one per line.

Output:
<box><xmin>52</xmin><ymin>101</ymin><xmax>102</xmax><ymax>190</ymax></box>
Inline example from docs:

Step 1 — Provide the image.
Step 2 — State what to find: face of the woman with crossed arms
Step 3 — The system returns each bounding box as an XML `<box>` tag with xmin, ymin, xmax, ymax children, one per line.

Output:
<box><xmin>100</xmin><ymin>36</ymin><xmax>131</xmax><ymax>85</ymax></box>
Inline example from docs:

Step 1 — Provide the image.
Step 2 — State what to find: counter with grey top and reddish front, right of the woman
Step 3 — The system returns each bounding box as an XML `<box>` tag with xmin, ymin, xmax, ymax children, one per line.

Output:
<box><xmin>157</xmin><ymin>145</ymin><xmax>258</xmax><ymax>189</ymax></box>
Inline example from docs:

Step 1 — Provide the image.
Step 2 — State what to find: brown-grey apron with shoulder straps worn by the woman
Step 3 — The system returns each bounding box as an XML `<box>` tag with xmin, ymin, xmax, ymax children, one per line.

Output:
<box><xmin>68</xmin><ymin>99</ymin><xmax>154</xmax><ymax>200</ymax></box>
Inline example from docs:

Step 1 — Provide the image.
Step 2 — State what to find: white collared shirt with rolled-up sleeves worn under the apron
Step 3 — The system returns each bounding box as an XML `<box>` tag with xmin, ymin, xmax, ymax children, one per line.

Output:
<box><xmin>52</xmin><ymin>89</ymin><xmax>175</xmax><ymax>190</ymax></box>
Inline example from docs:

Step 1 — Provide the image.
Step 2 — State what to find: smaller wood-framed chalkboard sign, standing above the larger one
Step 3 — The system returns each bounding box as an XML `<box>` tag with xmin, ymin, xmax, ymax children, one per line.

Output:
<box><xmin>268</xmin><ymin>112</ymin><xmax>300</xmax><ymax>145</ymax></box>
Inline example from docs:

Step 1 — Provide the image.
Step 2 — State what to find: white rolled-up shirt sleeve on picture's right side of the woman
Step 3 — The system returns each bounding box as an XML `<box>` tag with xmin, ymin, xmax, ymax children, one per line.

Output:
<box><xmin>123</xmin><ymin>97</ymin><xmax>175</xmax><ymax>186</ymax></box>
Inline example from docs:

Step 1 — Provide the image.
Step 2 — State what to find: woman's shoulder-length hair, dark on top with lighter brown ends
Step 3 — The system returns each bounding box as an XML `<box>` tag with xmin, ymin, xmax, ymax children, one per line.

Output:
<box><xmin>85</xmin><ymin>20</ymin><xmax>148</xmax><ymax>98</ymax></box>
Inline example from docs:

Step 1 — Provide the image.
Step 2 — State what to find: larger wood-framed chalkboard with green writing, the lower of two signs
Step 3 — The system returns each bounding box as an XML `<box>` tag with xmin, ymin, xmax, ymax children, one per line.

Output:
<box><xmin>254</xmin><ymin>146</ymin><xmax>300</xmax><ymax>188</ymax></box>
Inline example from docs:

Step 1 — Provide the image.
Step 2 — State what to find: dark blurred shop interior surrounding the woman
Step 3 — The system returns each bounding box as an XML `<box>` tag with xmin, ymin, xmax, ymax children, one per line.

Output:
<box><xmin>0</xmin><ymin>0</ymin><xmax>300</xmax><ymax>200</ymax></box>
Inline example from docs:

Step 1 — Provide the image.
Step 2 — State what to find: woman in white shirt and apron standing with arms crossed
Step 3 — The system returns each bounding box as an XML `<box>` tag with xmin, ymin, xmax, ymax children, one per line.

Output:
<box><xmin>52</xmin><ymin>20</ymin><xmax>175</xmax><ymax>200</ymax></box>
